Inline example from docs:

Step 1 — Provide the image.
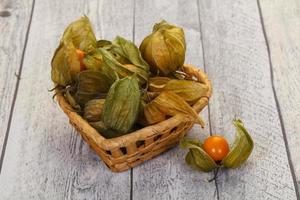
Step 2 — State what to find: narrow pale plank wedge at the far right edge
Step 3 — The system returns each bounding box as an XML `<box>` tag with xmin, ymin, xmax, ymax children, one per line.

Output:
<box><xmin>260</xmin><ymin>0</ymin><xmax>300</xmax><ymax>194</ymax></box>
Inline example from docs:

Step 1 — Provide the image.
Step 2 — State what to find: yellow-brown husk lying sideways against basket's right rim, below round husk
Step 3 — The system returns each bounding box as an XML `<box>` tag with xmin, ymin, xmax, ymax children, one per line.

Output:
<box><xmin>162</xmin><ymin>79</ymin><xmax>208</xmax><ymax>104</ymax></box>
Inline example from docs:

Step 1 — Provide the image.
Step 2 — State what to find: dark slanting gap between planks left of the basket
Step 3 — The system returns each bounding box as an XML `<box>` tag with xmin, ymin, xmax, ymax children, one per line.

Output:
<box><xmin>0</xmin><ymin>0</ymin><xmax>35</xmax><ymax>174</ymax></box>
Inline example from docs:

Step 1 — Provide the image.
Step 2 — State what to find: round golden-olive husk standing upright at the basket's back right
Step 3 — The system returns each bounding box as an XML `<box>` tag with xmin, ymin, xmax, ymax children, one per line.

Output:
<box><xmin>140</xmin><ymin>20</ymin><xmax>186</xmax><ymax>76</ymax></box>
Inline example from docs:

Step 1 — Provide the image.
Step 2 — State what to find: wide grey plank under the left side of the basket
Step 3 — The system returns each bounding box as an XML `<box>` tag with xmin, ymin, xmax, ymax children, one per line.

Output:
<box><xmin>0</xmin><ymin>0</ymin><xmax>133</xmax><ymax>199</ymax></box>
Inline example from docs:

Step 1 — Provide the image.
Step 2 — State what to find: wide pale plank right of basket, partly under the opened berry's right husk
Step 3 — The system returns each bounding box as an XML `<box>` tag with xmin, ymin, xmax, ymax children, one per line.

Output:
<box><xmin>199</xmin><ymin>0</ymin><xmax>296</xmax><ymax>199</ymax></box>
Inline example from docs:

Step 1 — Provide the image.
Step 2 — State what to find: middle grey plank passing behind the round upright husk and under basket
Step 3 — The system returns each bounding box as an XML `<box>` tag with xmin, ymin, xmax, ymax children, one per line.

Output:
<box><xmin>133</xmin><ymin>0</ymin><xmax>217</xmax><ymax>199</ymax></box>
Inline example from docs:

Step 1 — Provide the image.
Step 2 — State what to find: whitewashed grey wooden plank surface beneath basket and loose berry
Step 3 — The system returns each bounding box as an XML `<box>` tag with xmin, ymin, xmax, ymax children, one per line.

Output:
<box><xmin>0</xmin><ymin>0</ymin><xmax>300</xmax><ymax>199</ymax></box>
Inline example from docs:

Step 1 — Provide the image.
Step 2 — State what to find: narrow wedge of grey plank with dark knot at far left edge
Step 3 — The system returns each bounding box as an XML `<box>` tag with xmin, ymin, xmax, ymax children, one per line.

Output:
<box><xmin>0</xmin><ymin>0</ymin><xmax>32</xmax><ymax>154</ymax></box>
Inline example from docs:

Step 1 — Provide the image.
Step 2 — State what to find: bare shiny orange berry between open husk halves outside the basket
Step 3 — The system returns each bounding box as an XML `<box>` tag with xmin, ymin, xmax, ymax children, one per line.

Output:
<box><xmin>203</xmin><ymin>135</ymin><xmax>229</xmax><ymax>161</ymax></box>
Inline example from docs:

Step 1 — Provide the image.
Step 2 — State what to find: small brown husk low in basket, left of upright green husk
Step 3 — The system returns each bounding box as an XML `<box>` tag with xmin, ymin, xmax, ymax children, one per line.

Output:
<box><xmin>83</xmin><ymin>99</ymin><xmax>105</xmax><ymax>122</ymax></box>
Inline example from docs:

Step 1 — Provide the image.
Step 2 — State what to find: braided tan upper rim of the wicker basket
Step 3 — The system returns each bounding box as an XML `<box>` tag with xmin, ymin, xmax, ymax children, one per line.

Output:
<box><xmin>56</xmin><ymin>64</ymin><xmax>212</xmax><ymax>150</ymax></box>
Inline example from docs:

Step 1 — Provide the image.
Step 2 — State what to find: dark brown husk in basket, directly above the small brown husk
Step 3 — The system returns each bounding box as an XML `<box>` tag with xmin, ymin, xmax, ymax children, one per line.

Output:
<box><xmin>75</xmin><ymin>70</ymin><xmax>117</xmax><ymax>106</ymax></box>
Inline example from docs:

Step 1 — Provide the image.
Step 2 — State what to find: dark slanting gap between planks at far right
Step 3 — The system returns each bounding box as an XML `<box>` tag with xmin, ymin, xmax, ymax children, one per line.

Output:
<box><xmin>257</xmin><ymin>0</ymin><xmax>300</xmax><ymax>199</ymax></box>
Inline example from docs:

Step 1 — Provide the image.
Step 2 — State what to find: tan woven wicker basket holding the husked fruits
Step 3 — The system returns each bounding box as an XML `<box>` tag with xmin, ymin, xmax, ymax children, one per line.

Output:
<box><xmin>56</xmin><ymin>65</ymin><xmax>211</xmax><ymax>172</ymax></box>
